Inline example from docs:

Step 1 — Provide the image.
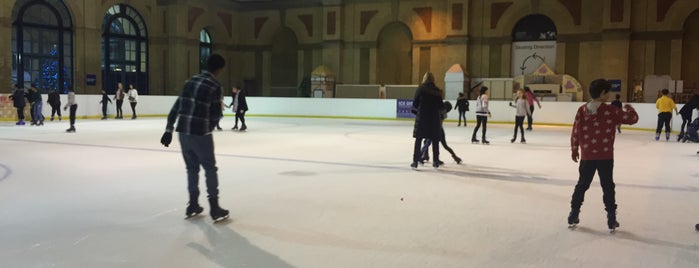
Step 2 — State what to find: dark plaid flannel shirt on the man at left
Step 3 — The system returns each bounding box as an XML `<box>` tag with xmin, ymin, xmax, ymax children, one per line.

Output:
<box><xmin>165</xmin><ymin>71</ymin><xmax>223</xmax><ymax>136</ymax></box>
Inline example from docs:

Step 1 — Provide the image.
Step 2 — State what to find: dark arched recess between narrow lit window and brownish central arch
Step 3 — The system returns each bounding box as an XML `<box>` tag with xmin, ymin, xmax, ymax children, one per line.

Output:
<box><xmin>271</xmin><ymin>28</ymin><xmax>298</xmax><ymax>89</ymax></box>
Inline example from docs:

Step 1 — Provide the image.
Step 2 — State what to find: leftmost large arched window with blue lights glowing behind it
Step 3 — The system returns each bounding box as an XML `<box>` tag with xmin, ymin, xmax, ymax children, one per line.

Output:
<box><xmin>12</xmin><ymin>0</ymin><xmax>73</xmax><ymax>93</ymax></box>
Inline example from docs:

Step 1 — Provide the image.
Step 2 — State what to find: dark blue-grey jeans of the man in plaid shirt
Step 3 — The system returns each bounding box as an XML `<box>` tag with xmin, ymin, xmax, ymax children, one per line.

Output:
<box><xmin>179</xmin><ymin>133</ymin><xmax>218</xmax><ymax>199</ymax></box>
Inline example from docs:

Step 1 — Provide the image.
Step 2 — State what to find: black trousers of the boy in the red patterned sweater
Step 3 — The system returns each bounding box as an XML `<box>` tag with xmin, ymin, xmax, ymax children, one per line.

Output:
<box><xmin>570</xmin><ymin>159</ymin><xmax>616</xmax><ymax>211</ymax></box>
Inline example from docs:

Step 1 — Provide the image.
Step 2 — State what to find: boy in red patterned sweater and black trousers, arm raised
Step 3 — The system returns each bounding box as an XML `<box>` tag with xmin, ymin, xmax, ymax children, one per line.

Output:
<box><xmin>568</xmin><ymin>79</ymin><xmax>638</xmax><ymax>231</ymax></box>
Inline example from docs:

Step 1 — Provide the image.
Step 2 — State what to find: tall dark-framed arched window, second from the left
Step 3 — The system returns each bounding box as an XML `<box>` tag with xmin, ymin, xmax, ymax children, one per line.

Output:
<box><xmin>102</xmin><ymin>4</ymin><xmax>148</xmax><ymax>94</ymax></box>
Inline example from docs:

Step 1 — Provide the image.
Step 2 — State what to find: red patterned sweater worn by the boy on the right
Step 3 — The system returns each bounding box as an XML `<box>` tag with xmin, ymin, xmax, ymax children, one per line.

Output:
<box><xmin>570</xmin><ymin>103</ymin><xmax>638</xmax><ymax>160</ymax></box>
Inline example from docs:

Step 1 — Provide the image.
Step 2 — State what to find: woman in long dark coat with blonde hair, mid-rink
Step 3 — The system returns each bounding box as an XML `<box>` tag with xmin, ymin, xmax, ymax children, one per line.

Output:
<box><xmin>410</xmin><ymin>72</ymin><xmax>442</xmax><ymax>169</ymax></box>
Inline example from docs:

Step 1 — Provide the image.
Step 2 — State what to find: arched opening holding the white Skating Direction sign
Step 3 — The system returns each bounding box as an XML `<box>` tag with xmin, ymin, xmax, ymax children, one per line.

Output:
<box><xmin>512</xmin><ymin>14</ymin><xmax>558</xmax><ymax>76</ymax></box>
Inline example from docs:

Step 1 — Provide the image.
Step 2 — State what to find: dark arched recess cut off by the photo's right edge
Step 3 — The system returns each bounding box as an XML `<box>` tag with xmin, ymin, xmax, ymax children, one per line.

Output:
<box><xmin>682</xmin><ymin>10</ymin><xmax>699</xmax><ymax>89</ymax></box>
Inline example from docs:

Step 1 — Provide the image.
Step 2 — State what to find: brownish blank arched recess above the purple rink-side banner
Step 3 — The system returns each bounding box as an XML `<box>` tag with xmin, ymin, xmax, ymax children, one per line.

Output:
<box><xmin>376</xmin><ymin>22</ymin><xmax>413</xmax><ymax>85</ymax></box>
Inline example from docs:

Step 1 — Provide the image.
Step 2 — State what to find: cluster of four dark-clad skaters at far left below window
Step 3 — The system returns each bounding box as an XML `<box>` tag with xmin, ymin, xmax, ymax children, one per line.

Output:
<box><xmin>10</xmin><ymin>84</ymin><xmax>78</xmax><ymax>132</ymax></box>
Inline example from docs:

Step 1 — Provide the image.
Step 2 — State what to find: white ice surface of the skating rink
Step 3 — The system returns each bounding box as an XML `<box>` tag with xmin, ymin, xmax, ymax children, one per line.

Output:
<box><xmin>0</xmin><ymin>118</ymin><xmax>699</xmax><ymax>268</ymax></box>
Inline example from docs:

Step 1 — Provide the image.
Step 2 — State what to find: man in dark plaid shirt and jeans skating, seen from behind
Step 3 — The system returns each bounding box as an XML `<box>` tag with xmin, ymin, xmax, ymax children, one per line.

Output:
<box><xmin>160</xmin><ymin>54</ymin><xmax>228</xmax><ymax>221</ymax></box>
